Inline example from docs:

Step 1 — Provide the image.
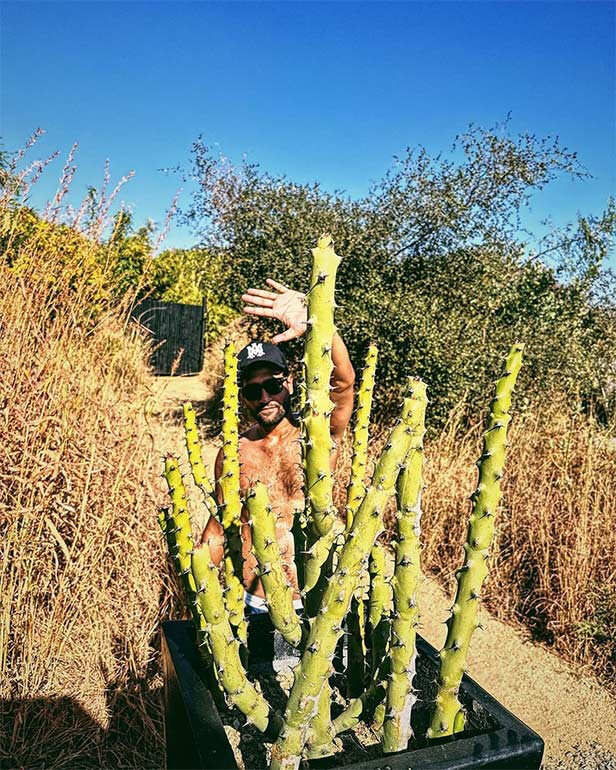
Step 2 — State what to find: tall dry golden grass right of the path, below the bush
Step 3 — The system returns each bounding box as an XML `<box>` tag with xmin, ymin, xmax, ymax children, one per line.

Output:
<box><xmin>422</xmin><ymin>398</ymin><xmax>616</xmax><ymax>686</ymax></box>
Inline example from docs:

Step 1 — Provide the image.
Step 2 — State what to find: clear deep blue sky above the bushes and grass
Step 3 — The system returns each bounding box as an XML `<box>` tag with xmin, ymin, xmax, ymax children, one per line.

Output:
<box><xmin>0</xmin><ymin>1</ymin><xmax>616</xmax><ymax>258</ymax></box>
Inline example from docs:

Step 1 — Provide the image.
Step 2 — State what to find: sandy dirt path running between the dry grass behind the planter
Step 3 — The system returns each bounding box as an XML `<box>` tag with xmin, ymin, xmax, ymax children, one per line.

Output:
<box><xmin>153</xmin><ymin>376</ymin><xmax>616</xmax><ymax>770</ymax></box>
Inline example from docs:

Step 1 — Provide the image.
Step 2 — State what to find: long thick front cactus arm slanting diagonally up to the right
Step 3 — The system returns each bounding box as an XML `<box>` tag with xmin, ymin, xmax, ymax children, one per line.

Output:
<box><xmin>271</xmin><ymin>381</ymin><xmax>428</xmax><ymax>770</ymax></box>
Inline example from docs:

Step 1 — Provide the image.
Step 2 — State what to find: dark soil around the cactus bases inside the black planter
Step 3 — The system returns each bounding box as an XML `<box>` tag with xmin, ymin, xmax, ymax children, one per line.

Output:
<box><xmin>214</xmin><ymin>657</ymin><xmax>498</xmax><ymax>770</ymax></box>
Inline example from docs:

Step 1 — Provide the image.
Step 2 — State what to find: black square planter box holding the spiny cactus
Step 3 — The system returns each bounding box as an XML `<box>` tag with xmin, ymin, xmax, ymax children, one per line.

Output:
<box><xmin>163</xmin><ymin>621</ymin><xmax>543</xmax><ymax>770</ymax></box>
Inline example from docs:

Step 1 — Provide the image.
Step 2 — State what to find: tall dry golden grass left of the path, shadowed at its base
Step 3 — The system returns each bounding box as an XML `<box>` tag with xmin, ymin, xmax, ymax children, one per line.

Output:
<box><xmin>0</xmin><ymin>147</ymin><xmax>170</xmax><ymax>768</ymax></box>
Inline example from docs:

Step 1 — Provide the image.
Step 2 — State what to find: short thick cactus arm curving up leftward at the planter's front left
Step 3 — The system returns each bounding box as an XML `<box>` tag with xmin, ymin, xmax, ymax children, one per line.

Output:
<box><xmin>192</xmin><ymin>546</ymin><xmax>277</xmax><ymax>732</ymax></box>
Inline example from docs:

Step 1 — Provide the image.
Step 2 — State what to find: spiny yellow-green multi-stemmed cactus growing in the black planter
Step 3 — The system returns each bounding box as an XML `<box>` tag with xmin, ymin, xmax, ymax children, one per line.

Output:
<box><xmin>159</xmin><ymin>231</ymin><xmax>521</xmax><ymax>770</ymax></box>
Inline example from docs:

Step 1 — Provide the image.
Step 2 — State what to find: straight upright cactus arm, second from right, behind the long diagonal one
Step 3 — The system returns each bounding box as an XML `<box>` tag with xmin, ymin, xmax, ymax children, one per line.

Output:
<box><xmin>383</xmin><ymin>384</ymin><xmax>425</xmax><ymax>752</ymax></box>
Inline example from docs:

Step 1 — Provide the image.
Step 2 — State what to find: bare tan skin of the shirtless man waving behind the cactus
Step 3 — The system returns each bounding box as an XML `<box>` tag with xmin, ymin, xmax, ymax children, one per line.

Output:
<box><xmin>201</xmin><ymin>278</ymin><xmax>355</xmax><ymax>599</ymax></box>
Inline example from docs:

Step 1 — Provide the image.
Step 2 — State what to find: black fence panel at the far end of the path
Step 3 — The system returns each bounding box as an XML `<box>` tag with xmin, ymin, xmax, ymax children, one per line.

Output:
<box><xmin>132</xmin><ymin>299</ymin><xmax>205</xmax><ymax>375</ymax></box>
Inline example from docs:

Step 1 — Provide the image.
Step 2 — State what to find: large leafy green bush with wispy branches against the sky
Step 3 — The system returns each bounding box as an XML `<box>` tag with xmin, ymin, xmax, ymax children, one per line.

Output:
<box><xmin>180</xmin><ymin>121</ymin><xmax>616</xmax><ymax>425</ymax></box>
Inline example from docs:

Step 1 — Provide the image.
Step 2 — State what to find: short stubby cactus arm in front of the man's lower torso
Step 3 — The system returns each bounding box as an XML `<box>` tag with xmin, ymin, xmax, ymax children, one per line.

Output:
<box><xmin>246</xmin><ymin>482</ymin><xmax>302</xmax><ymax>647</ymax></box>
